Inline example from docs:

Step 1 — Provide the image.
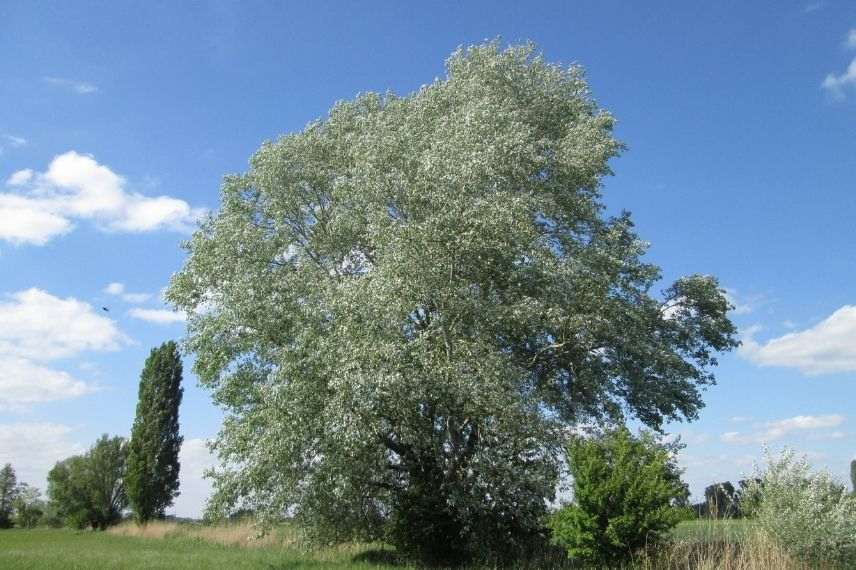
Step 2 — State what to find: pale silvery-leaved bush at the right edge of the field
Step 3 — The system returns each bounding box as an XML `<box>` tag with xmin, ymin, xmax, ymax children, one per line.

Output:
<box><xmin>749</xmin><ymin>449</ymin><xmax>856</xmax><ymax>567</ymax></box>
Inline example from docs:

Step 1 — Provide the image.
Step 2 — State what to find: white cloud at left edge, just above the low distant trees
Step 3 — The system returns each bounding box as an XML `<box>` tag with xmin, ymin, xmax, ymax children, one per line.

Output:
<box><xmin>0</xmin><ymin>289</ymin><xmax>128</xmax><ymax>410</ymax></box>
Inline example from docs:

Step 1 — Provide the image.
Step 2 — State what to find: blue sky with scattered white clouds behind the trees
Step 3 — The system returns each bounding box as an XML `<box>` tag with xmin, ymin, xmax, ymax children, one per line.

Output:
<box><xmin>0</xmin><ymin>0</ymin><xmax>856</xmax><ymax>515</ymax></box>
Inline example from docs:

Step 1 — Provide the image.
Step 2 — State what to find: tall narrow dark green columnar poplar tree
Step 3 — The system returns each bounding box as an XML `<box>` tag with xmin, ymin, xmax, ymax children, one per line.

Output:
<box><xmin>126</xmin><ymin>341</ymin><xmax>184</xmax><ymax>523</ymax></box>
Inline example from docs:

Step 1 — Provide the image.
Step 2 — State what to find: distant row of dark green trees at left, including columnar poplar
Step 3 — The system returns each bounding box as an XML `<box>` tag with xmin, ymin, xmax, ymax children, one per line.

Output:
<box><xmin>0</xmin><ymin>341</ymin><xmax>183</xmax><ymax>530</ymax></box>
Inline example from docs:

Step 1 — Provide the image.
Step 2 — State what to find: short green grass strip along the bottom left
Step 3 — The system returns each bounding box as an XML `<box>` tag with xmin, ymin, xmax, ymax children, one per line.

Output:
<box><xmin>0</xmin><ymin>529</ymin><xmax>401</xmax><ymax>570</ymax></box>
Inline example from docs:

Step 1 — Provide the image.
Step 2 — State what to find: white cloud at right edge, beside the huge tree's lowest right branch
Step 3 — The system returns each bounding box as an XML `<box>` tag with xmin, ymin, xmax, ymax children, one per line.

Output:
<box><xmin>739</xmin><ymin>305</ymin><xmax>856</xmax><ymax>376</ymax></box>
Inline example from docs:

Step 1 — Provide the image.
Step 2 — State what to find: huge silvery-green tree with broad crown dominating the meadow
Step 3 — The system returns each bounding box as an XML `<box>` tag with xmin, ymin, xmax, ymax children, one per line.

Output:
<box><xmin>168</xmin><ymin>42</ymin><xmax>736</xmax><ymax>551</ymax></box>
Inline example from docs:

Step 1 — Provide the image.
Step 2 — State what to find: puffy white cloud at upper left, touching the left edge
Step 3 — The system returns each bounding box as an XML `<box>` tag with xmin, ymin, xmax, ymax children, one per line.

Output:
<box><xmin>0</xmin><ymin>151</ymin><xmax>204</xmax><ymax>245</ymax></box>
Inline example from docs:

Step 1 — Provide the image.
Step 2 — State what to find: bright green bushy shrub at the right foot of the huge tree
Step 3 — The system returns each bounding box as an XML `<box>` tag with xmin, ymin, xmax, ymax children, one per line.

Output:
<box><xmin>549</xmin><ymin>427</ymin><xmax>685</xmax><ymax>565</ymax></box>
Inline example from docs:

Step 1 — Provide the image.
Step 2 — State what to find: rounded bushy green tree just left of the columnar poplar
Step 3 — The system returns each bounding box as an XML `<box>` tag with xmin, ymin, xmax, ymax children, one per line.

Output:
<box><xmin>48</xmin><ymin>434</ymin><xmax>128</xmax><ymax>530</ymax></box>
